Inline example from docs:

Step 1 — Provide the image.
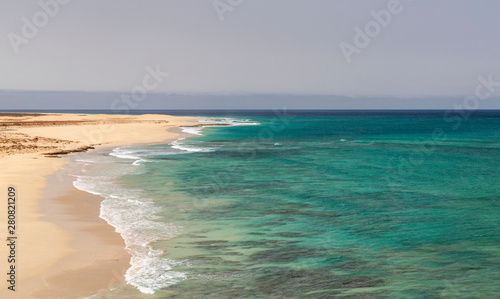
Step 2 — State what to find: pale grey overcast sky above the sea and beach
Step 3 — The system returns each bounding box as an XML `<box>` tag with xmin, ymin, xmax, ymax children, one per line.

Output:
<box><xmin>0</xmin><ymin>0</ymin><xmax>500</xmax><ymax>109</ymax></box>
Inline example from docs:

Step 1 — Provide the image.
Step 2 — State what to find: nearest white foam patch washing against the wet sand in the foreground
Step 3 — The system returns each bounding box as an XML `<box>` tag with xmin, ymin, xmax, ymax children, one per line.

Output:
<box><xmin>73</xmin><ymin>158</ymin><xmax>186</xmax><ymax>294</ymax></box>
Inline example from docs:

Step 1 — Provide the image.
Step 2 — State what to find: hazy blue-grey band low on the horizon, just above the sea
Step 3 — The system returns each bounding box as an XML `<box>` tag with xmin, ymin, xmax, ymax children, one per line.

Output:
<box><xmin>0</xmin><ymin>90</ymin><xmax>500</xmax><ymax>113</ymax></box>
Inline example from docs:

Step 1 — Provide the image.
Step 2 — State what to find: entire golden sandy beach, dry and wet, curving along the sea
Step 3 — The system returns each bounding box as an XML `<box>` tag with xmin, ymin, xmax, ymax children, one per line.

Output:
<box><xmin>0</xmin><ymin>114</ymin><xmax>205</xmax><ymax>298</ymax></box>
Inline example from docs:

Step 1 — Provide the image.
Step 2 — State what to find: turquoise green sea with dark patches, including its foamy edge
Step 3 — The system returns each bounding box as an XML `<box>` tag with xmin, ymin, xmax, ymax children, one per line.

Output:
<box><xmin>71</xmin><ymin>114</ymin><xmax>500</xmax><ymax>298</ymax></box>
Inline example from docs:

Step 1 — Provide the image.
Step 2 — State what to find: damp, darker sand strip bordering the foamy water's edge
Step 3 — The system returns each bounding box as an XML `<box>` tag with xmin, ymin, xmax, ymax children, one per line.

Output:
<box><xmin>27</xmin><ymin>162</ymin><xmax>130</xmax><ymax>298</ymax></box>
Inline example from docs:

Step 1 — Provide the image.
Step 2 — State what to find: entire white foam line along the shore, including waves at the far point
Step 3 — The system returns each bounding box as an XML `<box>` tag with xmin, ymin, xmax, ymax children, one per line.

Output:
<box><xmin>73</xmin><ymin>118</ymin><xmax>258</xmax><ymax>294</ymax></box>
